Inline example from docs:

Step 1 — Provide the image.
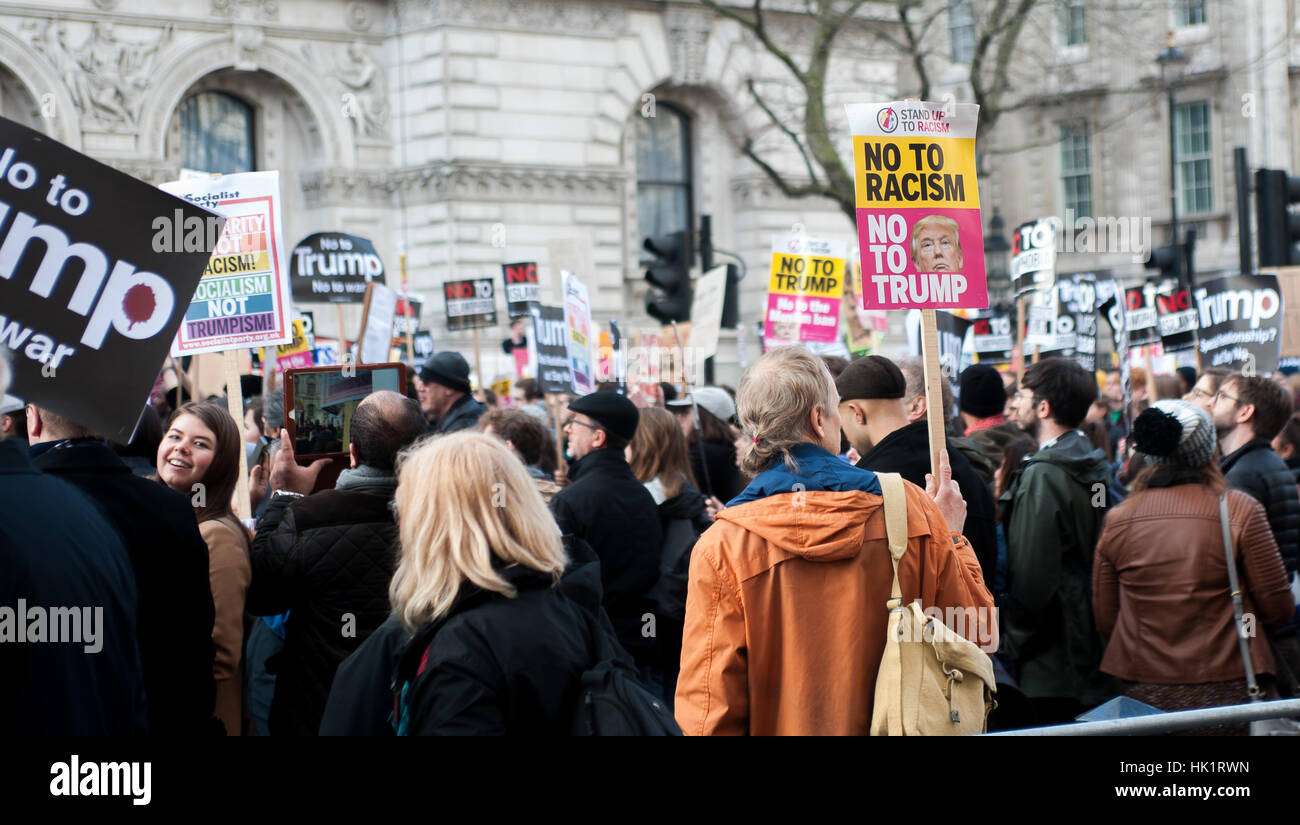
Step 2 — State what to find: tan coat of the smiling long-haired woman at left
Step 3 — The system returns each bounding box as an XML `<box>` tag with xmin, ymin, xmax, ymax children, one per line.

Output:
<box><xmin>199</xmin><ymin>517</ymin><xmax>252</xmax><ymax>737</ymax></box>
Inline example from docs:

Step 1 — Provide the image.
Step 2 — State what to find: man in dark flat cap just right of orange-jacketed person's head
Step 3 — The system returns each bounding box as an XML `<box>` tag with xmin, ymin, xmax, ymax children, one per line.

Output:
<box><xmin>835</xmin><ymin>355</ymin><xmax>997</xmax><ymax>582</ymax></box>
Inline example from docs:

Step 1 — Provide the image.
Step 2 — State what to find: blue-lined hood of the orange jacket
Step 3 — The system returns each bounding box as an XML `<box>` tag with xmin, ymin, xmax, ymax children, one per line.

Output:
<box><xmin>718</xmin><ymin>444</ymin><xmax>881</xmax><ymax>561</ymax></box>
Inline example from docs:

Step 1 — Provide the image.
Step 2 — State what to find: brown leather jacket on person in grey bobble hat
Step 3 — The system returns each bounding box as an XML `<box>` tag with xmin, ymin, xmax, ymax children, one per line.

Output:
<box><xmin>1092</xmin><ymin>485</ymin><xmax>1295</xmax><ymax>685</ymax></box>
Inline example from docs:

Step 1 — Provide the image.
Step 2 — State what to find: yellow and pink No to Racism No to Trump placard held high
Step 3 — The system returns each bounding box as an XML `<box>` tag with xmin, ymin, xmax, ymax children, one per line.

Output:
<box><xmin>845</xmin><ymin>100</ymin><xmax>988</xmax><ymax>309</ymax></box>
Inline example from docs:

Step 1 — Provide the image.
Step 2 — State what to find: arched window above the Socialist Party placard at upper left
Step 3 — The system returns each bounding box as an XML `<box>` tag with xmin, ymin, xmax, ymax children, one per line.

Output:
<box><xmin>181</xmin><ymin>92</ymin><xmax>254</xmax><ymax>174</ymax></box>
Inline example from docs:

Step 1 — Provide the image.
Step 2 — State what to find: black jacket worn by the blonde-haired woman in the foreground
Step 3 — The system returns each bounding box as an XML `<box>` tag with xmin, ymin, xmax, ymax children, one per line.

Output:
<box><xmin>321</xmin><ymin>537</ymin><xmax>607</xmax><ymax>735</ymax></box>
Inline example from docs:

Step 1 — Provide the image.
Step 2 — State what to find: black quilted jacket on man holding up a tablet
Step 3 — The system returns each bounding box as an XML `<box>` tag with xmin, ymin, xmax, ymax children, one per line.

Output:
<box><xmin>247</xmin><ymin>479</ymin><xmax>398</xmax><ymax>735</ymax></box>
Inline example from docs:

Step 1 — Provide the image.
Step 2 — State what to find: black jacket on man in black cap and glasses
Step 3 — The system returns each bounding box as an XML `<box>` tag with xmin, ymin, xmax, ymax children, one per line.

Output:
<box><xmin>551</xmin><ymin>450</ymin><xmax>663</xmax><ymax>663</ymax></box>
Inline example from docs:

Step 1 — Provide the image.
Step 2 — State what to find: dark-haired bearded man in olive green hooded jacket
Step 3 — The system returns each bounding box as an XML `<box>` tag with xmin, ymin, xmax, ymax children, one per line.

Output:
<box><xmin>1000</xmin><ymin>359</ymin><xmax>1117</xmax><ymax>724</ymax></box>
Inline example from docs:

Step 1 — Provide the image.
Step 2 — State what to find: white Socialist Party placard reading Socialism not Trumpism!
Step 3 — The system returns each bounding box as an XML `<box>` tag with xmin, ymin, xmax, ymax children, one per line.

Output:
<box><xmin>159</xmin><ymin>171</ymin><xmax>293</xmax><ymax>356</ymax></box>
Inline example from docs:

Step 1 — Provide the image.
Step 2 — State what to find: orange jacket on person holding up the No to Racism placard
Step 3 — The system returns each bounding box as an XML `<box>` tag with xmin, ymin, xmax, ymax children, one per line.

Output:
<box><xmin>676</xmin><ymin>482</ymin><xmax>997</xmax><ymax>735</ymax></box>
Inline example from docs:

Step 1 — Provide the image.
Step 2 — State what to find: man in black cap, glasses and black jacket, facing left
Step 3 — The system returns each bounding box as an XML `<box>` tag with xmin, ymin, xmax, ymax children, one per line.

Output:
<box><xmin>551</xmin><ymin>392</ymin><xmax>663</xmax><ymax>664</ymax></box>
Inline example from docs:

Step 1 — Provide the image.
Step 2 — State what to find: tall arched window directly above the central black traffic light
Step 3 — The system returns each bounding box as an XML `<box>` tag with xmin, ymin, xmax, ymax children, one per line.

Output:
<box><xmin>636</xmin><ymin>103</ymin><xmax>692</xmax><ymax>248</ymax></box>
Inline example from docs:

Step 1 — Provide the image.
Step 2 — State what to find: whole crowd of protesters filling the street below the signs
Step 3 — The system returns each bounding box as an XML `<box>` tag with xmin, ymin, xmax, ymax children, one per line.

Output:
<box><xmin>0</xmin><ymin>337</ymin><xmax>1300</xmax><ymax>737</ymax></box>
